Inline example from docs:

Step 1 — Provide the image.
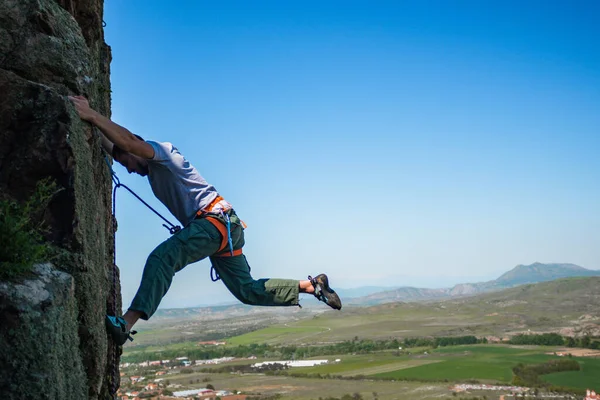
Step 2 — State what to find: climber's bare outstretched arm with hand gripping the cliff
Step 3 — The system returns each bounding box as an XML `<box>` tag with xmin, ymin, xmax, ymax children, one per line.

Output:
<box><xmin>69</xmin><ymin>96</ymin><xmax>154</xmax><ymax>159</ymax></box>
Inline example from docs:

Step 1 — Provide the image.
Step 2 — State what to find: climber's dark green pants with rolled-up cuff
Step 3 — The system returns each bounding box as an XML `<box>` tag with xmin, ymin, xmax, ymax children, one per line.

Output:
<box><xmin>129</xmin><ymin>210</ymin><xmax>299</xmax><ymax>320</ymax></box>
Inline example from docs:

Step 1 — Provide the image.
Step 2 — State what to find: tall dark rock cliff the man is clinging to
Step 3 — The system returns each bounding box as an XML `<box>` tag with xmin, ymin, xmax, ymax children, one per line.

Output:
<box><xmin>0</xmin><ymin>0</ymin><xmax>120</xmax><ymax>400</ymax></box>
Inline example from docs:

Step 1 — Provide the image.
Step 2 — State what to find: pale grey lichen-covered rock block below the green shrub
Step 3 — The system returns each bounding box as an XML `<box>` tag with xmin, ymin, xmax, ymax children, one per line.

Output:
<box><xmin>0</xmin><ymin>264</ymin><xmax>87</xmax><ymax>399</ymax></box>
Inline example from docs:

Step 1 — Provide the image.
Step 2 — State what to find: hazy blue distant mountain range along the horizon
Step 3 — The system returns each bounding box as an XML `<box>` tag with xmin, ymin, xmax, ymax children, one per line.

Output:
<box><xmin>342</xmin><ymin>262</ymin><xmax>600</xmax><ymax>306</ymax></box>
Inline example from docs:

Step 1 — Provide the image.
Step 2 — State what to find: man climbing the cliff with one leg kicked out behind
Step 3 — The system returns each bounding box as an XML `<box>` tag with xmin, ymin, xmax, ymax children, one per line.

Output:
<box><xmin>69</xmin><ymin>96</ymin><xmax>342</xmax><ymax>345</ymax></box>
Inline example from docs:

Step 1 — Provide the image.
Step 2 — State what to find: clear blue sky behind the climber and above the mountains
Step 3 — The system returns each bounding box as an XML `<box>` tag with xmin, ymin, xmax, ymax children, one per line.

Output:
<box><xmin>104</xmin><ymin>0</ymin><xmax>600</xmax><ymax>307</ymax></box>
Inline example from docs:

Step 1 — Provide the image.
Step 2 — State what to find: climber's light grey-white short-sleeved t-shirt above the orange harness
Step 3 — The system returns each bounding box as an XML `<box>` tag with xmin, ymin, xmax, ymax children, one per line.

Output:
<box><xmin>146</xmin><ymin>141</ymin><xmax>219</xmax><ymax>226</ymax></box>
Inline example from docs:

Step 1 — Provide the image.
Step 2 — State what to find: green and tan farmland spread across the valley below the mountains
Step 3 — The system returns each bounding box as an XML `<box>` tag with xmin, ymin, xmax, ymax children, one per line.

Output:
<box><xmin>123</xmin><ymin>279</ymin><xmax>600</xmax><ymax>400</ymax></box>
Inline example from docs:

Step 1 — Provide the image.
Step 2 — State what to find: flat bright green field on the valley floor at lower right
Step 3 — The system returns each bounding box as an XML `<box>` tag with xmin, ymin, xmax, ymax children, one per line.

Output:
<box><xmin>278</xmin><ymin>345</ymin><xmax>600</xmax><ymax>389</ymax></box>
